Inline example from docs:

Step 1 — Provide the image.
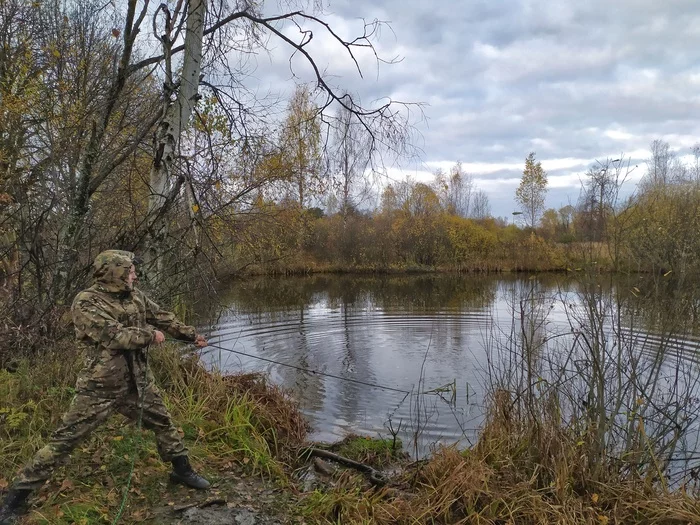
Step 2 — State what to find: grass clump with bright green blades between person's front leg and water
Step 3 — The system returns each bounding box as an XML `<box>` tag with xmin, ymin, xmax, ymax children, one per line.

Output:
<box><xmin>151</xmin><ymin>347</ymin><xmax>308</xmax><ymax>472</ymax></box>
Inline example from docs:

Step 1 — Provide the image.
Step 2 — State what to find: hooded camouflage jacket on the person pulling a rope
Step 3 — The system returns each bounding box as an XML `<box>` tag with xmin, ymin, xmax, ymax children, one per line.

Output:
<box><xmin>71</xmin><ymin>250</ymin><xmax>195</xmax><ymax>397</ymax></box>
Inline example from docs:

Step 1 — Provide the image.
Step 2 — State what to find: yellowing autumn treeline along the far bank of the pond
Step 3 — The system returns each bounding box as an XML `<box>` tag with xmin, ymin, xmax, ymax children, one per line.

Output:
<box><xmin>235</xmin><ymin>140</ymin><xmax>700</xmax><ymax>276</ymax></box>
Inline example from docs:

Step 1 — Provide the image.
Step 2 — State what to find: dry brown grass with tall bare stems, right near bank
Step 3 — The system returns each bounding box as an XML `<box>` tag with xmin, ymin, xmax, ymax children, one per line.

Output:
<box><xmin>302</xmin><ymin>275</ymin><xmax>700</xmax><ymax>524</ymax></box>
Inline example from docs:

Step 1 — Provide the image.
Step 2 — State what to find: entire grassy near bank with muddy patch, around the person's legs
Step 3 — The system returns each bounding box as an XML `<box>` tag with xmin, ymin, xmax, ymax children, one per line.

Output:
<box><xmin>0</xmin><ymin>346</ymin><xmax>700</xmax><ymax>524</ymax></box>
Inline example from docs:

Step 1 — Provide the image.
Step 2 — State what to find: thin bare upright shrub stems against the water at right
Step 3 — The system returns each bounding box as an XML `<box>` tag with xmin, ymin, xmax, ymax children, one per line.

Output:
<box><xmin>489</xmin><ymin>278</ymin><xmax>700</xmax><ymax>489</ymax></box>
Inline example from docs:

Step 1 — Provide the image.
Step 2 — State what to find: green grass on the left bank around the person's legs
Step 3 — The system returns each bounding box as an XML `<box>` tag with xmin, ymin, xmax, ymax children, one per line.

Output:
<box><xmin>0</xmin><ymin>345</ymin><xmax>307</xmax><ymax>524</ymax></box>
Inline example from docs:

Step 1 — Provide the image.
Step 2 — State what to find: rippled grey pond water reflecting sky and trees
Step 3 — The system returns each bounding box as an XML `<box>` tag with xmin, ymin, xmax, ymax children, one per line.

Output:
<box><xmin>205</xmin><ymin>275</ymin><xmax>700</xmax><ymax>456</ymax></box>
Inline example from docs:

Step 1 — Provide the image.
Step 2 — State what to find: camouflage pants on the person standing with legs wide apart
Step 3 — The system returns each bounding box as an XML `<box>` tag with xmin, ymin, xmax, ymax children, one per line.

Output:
<box><xmin>14</xmin><ymin>384</ymin><xmax>187</xmax><ymax>489</ymax></box>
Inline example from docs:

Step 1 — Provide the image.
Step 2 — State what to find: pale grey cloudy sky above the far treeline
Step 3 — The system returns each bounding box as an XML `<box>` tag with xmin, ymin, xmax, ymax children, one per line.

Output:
<box><xmin>256</xmin><ymin>0</ymin><xmax>700</xmax><ymax>215</ymax></box>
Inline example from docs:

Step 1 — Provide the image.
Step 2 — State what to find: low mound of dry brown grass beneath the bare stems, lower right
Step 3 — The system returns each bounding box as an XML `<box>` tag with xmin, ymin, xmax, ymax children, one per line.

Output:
<box><xmin>302</xmin><ymin>390</ymin><xmax>700</xmax><ymax>525</ymax></box>
